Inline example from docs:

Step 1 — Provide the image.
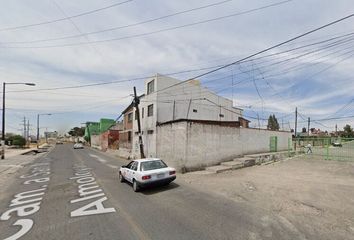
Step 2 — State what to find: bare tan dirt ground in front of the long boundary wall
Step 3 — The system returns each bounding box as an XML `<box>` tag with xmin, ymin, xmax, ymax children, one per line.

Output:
<box><xmin>179</xmin><ymin>157</ymin><xmax>354</xmax><ymax>239</ymax></box>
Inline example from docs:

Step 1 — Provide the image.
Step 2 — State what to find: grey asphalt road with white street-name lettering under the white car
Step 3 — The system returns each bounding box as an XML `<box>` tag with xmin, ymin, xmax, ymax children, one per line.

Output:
<box><xmin>0</xmin><ymin>144</ymin><xmax>299</xmax><ymax>240</ymax></box>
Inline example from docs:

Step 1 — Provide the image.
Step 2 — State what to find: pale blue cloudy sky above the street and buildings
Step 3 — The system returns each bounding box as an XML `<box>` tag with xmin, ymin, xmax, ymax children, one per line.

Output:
<box><xmin>0</xmin><ymin>0</ymin><xmax>354</xmax><ymax>134</ymax></box>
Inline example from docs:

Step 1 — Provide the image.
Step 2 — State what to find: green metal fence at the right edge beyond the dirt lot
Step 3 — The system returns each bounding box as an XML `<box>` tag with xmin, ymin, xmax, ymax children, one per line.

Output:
<box><xmin>292</xmin><ymin>137</ymin><xmax>354</xmax><ymax>162</ymax></box>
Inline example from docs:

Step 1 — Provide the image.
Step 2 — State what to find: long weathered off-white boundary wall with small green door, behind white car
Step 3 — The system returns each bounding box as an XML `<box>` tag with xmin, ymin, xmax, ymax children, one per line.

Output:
<box><xmin>157</xmin><ymin>122</ymin><xmax>291</xmax><ymax>171</ymax></box>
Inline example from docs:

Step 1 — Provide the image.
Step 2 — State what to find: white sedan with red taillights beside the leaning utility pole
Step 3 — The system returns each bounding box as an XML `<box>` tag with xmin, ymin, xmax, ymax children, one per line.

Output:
<box><xmin>119</xmin><ymin>158</ymin><xmax>176</xmax><ymax>192</ymax></box>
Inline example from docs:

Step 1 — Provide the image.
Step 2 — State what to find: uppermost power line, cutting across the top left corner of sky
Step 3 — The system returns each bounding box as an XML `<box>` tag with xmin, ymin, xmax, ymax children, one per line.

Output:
<box><xmin>0</xmin><ymin>0</ymin><xmax>133</xmax><ymax>32</ymax></box>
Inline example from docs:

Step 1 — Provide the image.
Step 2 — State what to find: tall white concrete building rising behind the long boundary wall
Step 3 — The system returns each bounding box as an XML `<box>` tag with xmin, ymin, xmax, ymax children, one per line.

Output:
<box><xmin>132</xmin><ymin>74</ymin><xmax>242</xmax><ymax>158</ymax></box>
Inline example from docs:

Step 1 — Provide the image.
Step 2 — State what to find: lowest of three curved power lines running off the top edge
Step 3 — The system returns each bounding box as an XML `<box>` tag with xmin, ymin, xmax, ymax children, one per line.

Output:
<box><xmin>0</xmin><ymin>0</ymin><xmax>293</xmax><ymax>49</ymax></box>
